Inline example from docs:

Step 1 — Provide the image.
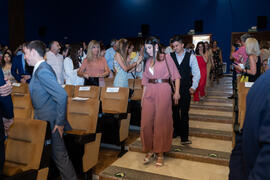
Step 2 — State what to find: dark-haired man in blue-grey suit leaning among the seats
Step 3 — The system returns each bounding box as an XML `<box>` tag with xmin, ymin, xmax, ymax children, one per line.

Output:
<box><xmin>24</xmin><ymin>41</ymin><xmax>77</xmax><ymax>180</ymax></box>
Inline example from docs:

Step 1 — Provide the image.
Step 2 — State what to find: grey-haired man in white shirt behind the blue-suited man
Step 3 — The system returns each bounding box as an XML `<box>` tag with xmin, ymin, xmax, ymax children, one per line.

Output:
<box><xmin>46</xmin><ymin>41</ymin><xmax>64</xmax><ymax>84</ymax></box>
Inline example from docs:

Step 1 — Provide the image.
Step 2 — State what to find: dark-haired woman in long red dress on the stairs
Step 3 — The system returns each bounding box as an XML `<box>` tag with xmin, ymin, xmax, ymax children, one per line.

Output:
<box><xmin>193</xmin><ymin>41</ymin><xmax>207</xmax><ymax>102</ymax></box>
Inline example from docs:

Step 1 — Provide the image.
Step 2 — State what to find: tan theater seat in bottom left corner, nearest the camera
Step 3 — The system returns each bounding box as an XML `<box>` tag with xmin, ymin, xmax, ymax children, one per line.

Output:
<box><xmin>2</xmin><ymin>118</ymin><xmax>50</xmax><ymax>180</ymax></box>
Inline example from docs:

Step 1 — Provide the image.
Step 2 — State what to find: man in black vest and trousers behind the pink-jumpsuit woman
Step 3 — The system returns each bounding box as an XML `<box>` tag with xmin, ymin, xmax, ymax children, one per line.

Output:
<box><xmin>171</xmin><ymin>35</ymin><xmax>201</xmax><ymax>145</ymax></box>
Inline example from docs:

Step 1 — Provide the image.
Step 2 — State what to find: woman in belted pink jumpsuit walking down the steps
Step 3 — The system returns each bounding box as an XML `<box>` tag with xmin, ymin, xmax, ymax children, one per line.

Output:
<box><xmin>141</xmin><ymin>37</ymin><xmax>180</xmax><ymax>166</ymax></box>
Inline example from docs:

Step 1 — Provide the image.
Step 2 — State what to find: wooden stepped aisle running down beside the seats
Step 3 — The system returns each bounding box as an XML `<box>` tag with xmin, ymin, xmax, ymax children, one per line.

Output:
<box><xmin>94</xmin><ymin>77</ymin><xmax>233</xmax><ymax>180</ymax></box>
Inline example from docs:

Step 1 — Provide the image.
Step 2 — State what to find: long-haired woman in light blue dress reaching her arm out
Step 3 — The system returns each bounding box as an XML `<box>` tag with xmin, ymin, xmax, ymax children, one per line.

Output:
<box><xmin>113</xmin><ymin>39</ymin><xmax>142</xmax><ymax>88</ymax></box>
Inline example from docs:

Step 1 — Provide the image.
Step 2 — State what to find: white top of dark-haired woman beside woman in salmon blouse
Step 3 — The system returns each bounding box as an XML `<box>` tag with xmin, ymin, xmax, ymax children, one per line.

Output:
<box><xmin>64</xmin><ymin>57</ymin><xmax>84</xmax><ymax>85</ymax></box>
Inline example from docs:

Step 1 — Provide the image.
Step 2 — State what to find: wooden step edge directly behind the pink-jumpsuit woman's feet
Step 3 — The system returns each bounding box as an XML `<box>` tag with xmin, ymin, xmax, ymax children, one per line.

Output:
<box><xmin>129</xmin><ymin>141</ymin><xmax>230</xmax><ymax>166</ymax></box>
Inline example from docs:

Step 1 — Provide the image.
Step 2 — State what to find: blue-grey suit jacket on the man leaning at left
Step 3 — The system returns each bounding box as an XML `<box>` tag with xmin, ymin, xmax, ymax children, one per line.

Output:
<box><xmin>29</xmin><ymin>62</ymin><xmax>70</xmax><ymax>130</ymax></box>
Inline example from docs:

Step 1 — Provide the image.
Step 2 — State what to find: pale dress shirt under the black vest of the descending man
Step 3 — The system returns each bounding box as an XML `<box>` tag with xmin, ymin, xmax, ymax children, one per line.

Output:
<box><xmin>175</xmin><ymin>50</ymin><xmax>201</xmax><ymax>90</ymax></box>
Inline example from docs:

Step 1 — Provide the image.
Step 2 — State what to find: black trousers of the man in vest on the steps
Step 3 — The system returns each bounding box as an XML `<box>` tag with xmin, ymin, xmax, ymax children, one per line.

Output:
<box><xmin>173</xmin><ymin>89</ymin><xmax>191</xmax><ymax>141</ymax></box>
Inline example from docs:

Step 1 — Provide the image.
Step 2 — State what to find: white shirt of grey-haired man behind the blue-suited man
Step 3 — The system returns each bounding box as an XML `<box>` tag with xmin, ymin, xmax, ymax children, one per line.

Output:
<box><xmin>46</xmin><ymin>51</ymin><xmax>64</xmax><ymax>84</ymax></box>
